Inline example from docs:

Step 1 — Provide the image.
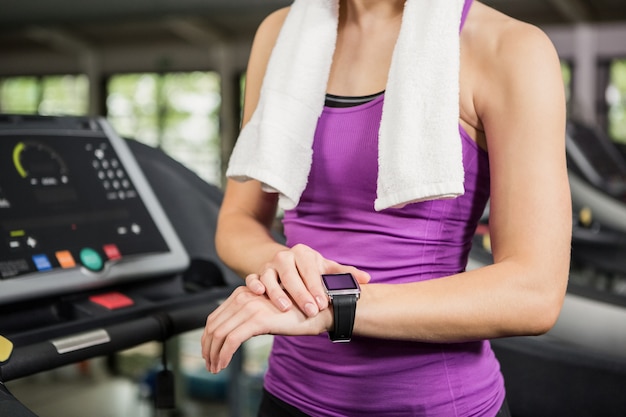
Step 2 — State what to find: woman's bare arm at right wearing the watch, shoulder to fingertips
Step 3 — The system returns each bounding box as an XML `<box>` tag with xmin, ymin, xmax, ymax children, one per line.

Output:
<box><xmin>203</xmin><ymin>9</ymin><xmax>571</xmax><ymax>372</ymax></box>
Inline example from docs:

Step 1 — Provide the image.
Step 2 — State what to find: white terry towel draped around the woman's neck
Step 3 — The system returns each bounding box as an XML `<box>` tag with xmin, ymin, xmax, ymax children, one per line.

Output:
<box><xmin>226</xmin><ymin>0</ymin><xmax>464</xmax><ymax>211</ymax></box>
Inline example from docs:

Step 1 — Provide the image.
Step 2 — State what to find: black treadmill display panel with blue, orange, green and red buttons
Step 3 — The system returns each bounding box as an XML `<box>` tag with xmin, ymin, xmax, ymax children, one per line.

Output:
<box><xmin>0</xmin><ymin>115</ymin><xmax>188</xmax><ymax>301</ymax></box>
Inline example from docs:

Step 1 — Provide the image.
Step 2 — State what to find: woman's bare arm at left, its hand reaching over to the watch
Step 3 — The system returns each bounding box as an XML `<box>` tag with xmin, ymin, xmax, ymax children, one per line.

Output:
<box><xmin>216</xmin><ymin>8</ymin><xmax>369</xmax><ymax>316</ymax></box>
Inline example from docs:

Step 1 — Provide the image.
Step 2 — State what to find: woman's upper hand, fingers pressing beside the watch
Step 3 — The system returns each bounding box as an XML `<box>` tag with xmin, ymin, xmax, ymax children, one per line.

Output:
<box><xmin>246</xmin><ymin>244</ymin><xmax>370</xmax><ymax>317</ymax></box>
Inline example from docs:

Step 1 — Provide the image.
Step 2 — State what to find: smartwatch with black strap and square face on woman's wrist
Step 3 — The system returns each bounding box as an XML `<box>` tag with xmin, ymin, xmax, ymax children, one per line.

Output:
<box><xmin>322</xmin><ymin>274</ymin><xmax>361</xmax><ymax>342</ymax></box>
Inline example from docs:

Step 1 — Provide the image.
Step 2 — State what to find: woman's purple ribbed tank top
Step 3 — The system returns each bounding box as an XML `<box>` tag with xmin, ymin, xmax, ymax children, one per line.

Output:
<box><xmin>265</xmin><ymin>1</ymin><xmax>504</xmax><ymax>417</ymax></box>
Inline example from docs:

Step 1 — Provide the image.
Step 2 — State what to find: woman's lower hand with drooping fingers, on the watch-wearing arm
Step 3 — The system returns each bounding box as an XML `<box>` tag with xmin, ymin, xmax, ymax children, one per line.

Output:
<box><xmin>201</xmin><ymin>286</ymin><xmax>332</xmax><ymax>373</ymax></box>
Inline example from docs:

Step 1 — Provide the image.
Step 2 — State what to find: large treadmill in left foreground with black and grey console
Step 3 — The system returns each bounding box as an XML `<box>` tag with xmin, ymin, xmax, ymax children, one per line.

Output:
<box><xmin>0</xmin><ymin>115</ymin><xmax>239</xmax><ymax>416</ymax></box>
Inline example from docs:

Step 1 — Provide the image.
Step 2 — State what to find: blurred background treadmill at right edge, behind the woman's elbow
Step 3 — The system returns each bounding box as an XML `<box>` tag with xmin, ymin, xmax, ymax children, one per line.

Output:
<box><xmin>549</xmin><ymin>121</ymin><xmax>626</xmax><ymax>359</ymax></box>
